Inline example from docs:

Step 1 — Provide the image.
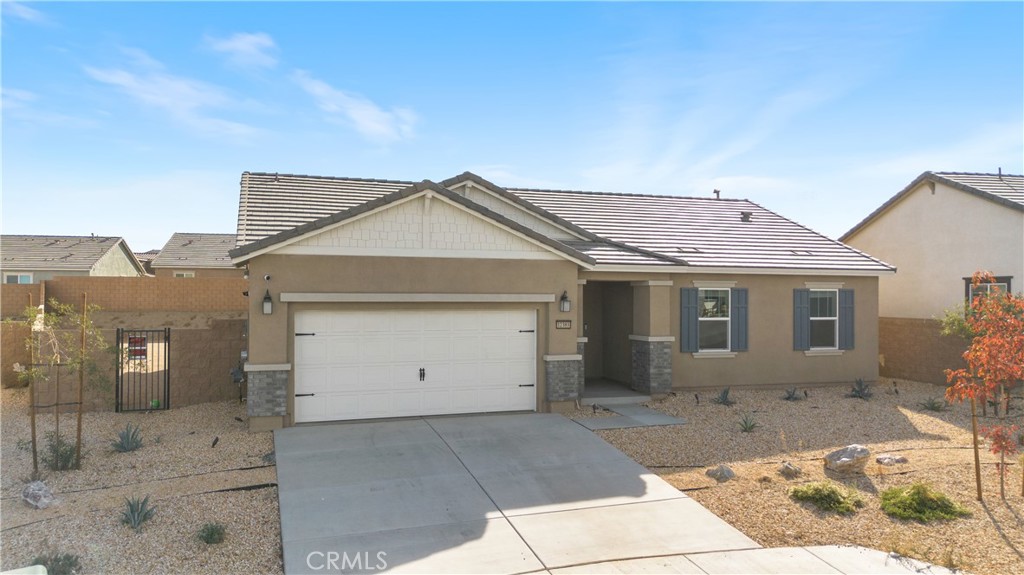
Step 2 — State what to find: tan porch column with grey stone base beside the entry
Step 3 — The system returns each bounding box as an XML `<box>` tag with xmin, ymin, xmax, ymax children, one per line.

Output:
<box><xmin>630</xmin><ymin>279</ymin><xmax>676</xmax><ymax>395</ymax></box>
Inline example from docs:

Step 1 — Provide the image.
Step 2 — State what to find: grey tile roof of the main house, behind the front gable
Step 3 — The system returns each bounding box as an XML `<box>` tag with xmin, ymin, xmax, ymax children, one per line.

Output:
<box><xmin>232</xmin><ymin>172</ymin><xmax>893</xmax><ymax>272</ymax></box>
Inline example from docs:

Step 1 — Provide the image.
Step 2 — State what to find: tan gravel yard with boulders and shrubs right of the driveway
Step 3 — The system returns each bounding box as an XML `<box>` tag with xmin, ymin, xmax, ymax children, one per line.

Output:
<box><xmin>573</xmin><ymin>380</ymin><xmax>1024</xmax><ymax>575</ymax></box>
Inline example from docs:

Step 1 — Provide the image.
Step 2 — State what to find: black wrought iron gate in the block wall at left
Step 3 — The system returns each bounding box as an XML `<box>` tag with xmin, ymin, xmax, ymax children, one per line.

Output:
<box><xmin>115</xmin><ymin>327</ymin><xmax>171</xmax><ymax>411</ymax></box>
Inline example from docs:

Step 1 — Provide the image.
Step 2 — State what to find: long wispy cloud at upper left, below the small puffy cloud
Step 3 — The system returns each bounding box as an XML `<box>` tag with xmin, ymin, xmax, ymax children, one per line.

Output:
<box><xmin>84</xmin><ymin>49</ymin><xmax>258</xmax><ymax>138</ymax></box>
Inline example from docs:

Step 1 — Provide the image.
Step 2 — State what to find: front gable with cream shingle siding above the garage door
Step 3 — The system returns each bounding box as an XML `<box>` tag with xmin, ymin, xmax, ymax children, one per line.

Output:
<box><xmin>231</xmin><ymin>181</ymin><xmax>593</xmax><ymax>265</ymax></box>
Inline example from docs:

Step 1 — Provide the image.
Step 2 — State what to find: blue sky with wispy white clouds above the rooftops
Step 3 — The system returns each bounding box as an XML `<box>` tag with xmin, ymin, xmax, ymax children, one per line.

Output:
<box><xmin>0</xmin><ymin>1</ymin><xmax>1024</xmax><ymax>251</ymax></box>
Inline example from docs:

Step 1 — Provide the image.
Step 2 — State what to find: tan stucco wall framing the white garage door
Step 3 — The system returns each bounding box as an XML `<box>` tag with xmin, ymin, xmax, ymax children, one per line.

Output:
<box><xmin>249</xmin><ymin>255</ymin><xmax>577</xmax><ymax>421</ymax></box>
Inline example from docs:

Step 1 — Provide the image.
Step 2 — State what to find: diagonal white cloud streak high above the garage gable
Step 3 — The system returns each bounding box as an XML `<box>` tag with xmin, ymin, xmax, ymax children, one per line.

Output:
<box><xmin>292</xmin><ymin>70</ymin><xmax>417</xmax><ymax>144</ymax></box>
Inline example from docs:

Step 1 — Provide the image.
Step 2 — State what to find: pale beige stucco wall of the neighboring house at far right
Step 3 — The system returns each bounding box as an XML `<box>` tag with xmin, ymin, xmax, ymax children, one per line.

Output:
<box><xmin>846</xmin><ymin>182</ymin><xmax>1024</xmax><ymax>319</ymax></box>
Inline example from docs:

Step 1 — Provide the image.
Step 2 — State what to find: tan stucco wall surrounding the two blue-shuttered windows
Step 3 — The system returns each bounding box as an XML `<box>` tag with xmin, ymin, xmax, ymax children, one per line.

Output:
<box><xmin>671</xmin><ymin>274</ymin><xmax>879</xmax><ymax>389</ymax></box>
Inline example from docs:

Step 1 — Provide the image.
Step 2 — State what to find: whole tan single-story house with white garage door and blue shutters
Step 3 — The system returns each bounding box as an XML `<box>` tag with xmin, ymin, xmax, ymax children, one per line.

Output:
<box><xmin>231</xmin><ymin>167</ymin><xmax>894</xmax><ymax>430</ymax></box>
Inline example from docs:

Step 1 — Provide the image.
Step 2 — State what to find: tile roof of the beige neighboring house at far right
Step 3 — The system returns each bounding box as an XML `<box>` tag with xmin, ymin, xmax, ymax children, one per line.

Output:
<box><xmin>840</xmin><ymin>172</ymin><xmax>1024</xmax><ymax>241</ymax></box>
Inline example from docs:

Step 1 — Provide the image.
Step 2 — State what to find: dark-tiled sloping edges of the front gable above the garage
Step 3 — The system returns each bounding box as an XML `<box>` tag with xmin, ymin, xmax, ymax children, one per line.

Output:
<box><xmin>230</xmin><ymin>180</ymin><xmax>594</xmax><ymax>264</ymax></box>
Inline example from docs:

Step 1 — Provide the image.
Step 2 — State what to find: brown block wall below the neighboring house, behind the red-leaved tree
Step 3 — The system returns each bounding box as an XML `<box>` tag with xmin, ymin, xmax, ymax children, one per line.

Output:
<box><xmin>879</xmin><ymin>317</ymin><xmax>968</xmax><ymax>386</ymax></box>
